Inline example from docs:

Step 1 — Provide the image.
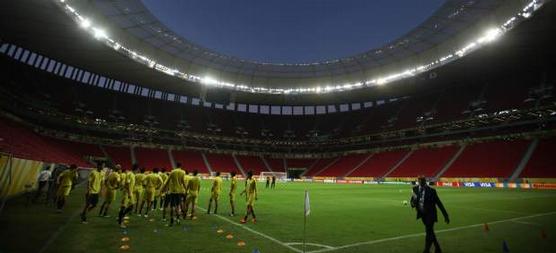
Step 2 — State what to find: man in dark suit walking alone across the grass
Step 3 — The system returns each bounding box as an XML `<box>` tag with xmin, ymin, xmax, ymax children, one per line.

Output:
<box><xmin>411</xmin><ymin>176</ymin><xmax>450</xmax><ymax>253</ymax></box>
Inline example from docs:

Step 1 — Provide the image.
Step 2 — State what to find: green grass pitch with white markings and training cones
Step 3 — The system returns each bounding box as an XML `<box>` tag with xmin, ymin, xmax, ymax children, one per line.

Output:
<box><xmin>0</xmin><ymin>182</ymin><xmax>556</xmax><ymax>253</ymax></box>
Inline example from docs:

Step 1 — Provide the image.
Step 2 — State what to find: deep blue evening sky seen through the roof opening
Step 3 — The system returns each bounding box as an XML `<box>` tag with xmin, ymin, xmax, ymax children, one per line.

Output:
<box><xmin>143</xmin><ymin>0</ymin><xmax>444</xmax><ymax>63</ymax></box>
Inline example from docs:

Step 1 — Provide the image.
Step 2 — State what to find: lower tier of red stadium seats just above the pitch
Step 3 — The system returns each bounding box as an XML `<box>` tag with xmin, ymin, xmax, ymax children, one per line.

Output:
<box><xmin>0</xmin><ymin>119</ymin><xmax>556</xmax><ymax>178</ymax></box>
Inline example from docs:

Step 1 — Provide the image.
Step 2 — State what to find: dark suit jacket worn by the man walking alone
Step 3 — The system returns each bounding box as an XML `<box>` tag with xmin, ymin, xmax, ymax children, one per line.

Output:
<box><xmin>411</xmin><ymin>186</ymin><xmax>449</xmax><ymax>222</ymax></box>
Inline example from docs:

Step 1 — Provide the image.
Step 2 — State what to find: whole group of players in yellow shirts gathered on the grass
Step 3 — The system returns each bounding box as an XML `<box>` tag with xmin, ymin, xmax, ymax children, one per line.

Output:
<box><xmin>52</xmin><ymin>163</ymin><xmax>257</xmax><ymax>227</ymax></box>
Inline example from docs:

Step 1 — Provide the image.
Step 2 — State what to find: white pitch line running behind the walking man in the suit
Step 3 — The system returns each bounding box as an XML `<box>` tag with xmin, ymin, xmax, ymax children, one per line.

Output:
<box><xmin>309</xmin><ymin>212</ymin><xmax>556</xmax><ymax>253</ymax></box>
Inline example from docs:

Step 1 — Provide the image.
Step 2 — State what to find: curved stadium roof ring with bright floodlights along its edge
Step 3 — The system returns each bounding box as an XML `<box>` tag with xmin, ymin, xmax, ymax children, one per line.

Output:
<box><xmin>2</xmin><ymin>0</ymin><xmax>545</xmax><ymax>98</ymax></box>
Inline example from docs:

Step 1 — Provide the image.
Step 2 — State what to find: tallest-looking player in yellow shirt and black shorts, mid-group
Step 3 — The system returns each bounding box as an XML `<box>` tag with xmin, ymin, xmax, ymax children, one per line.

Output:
<box><xmin>162</xmin><ymin>163</ymin><xmax>187</xmax><ymax>226</ymax></box>
